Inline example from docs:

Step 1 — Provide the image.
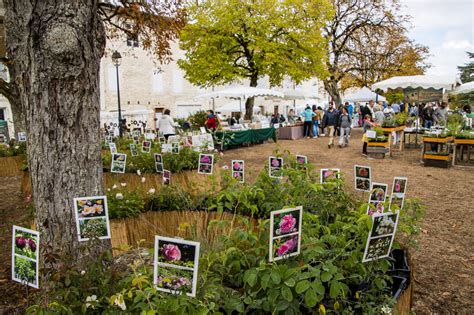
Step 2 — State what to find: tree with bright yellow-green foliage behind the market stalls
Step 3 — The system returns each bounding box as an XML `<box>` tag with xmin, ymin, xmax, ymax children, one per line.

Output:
<box><xmin>178</xmin><ymin>0</ymin><xmax>332</xmax><ymax>119</ymax></box>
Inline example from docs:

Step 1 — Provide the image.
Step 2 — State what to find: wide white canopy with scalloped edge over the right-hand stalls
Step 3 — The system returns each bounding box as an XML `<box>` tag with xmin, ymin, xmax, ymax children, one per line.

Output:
<box><xmin>372</xmin><ymin>75</ymin><xmax>459</xmax><ymax>91</ymax></box>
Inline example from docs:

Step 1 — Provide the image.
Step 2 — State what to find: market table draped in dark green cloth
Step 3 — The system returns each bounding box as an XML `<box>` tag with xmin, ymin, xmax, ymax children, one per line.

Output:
<box><xmin>214</xmin><ymin>127</ymin><xmax>277</xmax><ymax>150</ymax></box>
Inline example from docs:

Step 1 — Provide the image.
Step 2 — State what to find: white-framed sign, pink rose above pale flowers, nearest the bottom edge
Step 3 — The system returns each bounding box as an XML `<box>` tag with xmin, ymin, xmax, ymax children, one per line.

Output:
<box><xmin>153</xmin><ymin>236</ymin><xmax>200</xmax><ymax>297</ymax></box>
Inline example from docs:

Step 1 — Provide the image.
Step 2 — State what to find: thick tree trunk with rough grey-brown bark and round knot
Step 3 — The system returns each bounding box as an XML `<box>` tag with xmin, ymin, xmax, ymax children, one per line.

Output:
<box><xmin>4</xmin><ymin>0</ymin><xmax>110</xmax><ymax>267</ymax></box>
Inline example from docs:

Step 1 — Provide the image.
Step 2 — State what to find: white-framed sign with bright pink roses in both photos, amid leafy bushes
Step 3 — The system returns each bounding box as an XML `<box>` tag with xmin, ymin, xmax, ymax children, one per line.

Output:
<box><xmin>269</xmin><ymin>207</ymin><xmax>303</xmax><ymax>262</ymax></box>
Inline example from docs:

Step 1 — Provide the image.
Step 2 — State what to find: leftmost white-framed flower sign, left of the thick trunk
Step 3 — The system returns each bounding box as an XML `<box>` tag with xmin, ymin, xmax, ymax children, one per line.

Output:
<box><xmin>12</xmin><ymin>225</ymin><xmax>40</xmax><ymax>289</ymax></box>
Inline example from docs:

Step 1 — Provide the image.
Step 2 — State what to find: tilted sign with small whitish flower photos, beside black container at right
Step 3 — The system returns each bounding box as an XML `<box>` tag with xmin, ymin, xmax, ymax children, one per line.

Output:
<box><xmin>362</xmin><ymin>212</ymin><xmax>399</xmax><ymax>262</ymax></box>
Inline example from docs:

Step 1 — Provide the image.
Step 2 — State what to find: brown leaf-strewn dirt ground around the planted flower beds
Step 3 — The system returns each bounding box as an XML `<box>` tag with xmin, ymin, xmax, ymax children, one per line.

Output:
<box><xmin>0</xmin><ymin>130</ymin><xmax>474</xmax><ymax>314</ymax></box>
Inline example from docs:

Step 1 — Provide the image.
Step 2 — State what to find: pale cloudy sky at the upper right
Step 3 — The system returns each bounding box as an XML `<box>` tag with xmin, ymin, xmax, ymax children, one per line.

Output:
<box><xmin>400</xmin><ymin>0</ymin><xmax>474</xmax><ymax>75</ymax></box>
